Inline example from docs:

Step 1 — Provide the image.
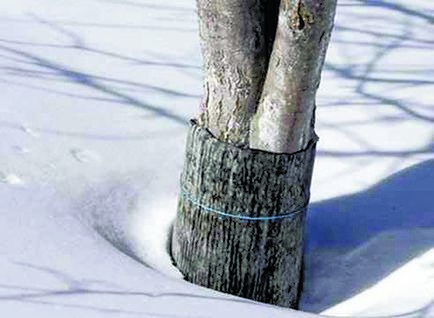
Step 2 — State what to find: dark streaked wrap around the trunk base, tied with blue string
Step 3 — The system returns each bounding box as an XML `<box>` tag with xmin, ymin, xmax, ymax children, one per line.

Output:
<box><xmin>172</xmin><ymin>121</ymin><xmax>317</xmax><ymax>307</ymax></box>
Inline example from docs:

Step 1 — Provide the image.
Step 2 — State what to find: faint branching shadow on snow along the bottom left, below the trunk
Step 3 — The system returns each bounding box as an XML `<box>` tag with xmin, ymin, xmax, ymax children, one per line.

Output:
<box><xmin>0</xmin><ymin>261</ymin><xmax>255</xmax><ymax>318</ymax></box>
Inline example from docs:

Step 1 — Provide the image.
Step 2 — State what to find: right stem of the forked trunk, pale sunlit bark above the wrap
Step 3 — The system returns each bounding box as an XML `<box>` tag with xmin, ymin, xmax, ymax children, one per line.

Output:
<box><xmin>250</xmin><ymin>0</ymin><xmax>336</xmax><ymax>153</ymax></box>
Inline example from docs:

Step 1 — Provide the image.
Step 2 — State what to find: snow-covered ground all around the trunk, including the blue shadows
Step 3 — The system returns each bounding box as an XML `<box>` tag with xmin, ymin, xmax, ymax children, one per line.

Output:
<box><xmin>0</xmin><ymin>0</ymin><xmax>434</xmax><ymax>318</ymax></box>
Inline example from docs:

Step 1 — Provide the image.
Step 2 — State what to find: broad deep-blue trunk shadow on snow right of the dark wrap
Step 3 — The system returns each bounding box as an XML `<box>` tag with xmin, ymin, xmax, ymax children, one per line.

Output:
<box><xmin>301</xmin><ymin>160</ymin><xmax>434</xmax><ymax>317</ymax></box>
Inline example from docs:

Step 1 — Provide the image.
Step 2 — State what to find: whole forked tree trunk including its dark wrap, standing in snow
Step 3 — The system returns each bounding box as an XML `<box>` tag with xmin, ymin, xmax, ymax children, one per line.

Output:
<box><xmin>172</xmin><ymin>0</ymin><xmax>336</xmax><ymax>307</ymax></box>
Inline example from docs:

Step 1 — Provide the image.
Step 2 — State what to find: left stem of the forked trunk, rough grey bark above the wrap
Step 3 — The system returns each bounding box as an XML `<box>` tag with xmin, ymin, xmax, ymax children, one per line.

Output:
<box><xmin>197</xmin><ymin>0</ymin><xmax>279</xmax><ymax>147</ymax></box>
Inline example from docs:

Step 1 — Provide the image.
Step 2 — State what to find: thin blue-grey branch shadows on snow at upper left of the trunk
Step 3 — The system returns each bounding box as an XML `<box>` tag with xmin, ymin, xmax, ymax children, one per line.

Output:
<box><xmin>0</xmin><ymin>15</ymin><xmax>200</xmax><ymax>129</ymax></box>
